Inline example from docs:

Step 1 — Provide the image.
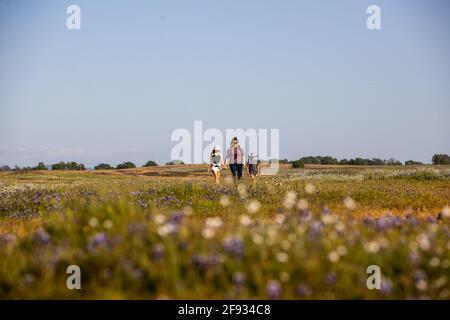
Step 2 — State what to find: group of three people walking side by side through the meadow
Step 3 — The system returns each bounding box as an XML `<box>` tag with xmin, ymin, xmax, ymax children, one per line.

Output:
<box><xmin>208</xmin><ymin>137</ymin><xmax>260</xmax><ymax>184</ymax></box>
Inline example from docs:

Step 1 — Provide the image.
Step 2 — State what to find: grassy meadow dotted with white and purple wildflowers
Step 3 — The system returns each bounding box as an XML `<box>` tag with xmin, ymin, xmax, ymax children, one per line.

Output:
<box><xmin>0</xmin><ymin>165</ymin><xmax>450</xmax><ymax>299</ymax></box>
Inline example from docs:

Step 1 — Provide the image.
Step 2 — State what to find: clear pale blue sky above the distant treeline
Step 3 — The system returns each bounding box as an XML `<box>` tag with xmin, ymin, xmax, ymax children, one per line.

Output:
<box><xmin>0</xmin><ymin>0</ymin><xmax>450</xmax><ymax>166</ymax></box>
